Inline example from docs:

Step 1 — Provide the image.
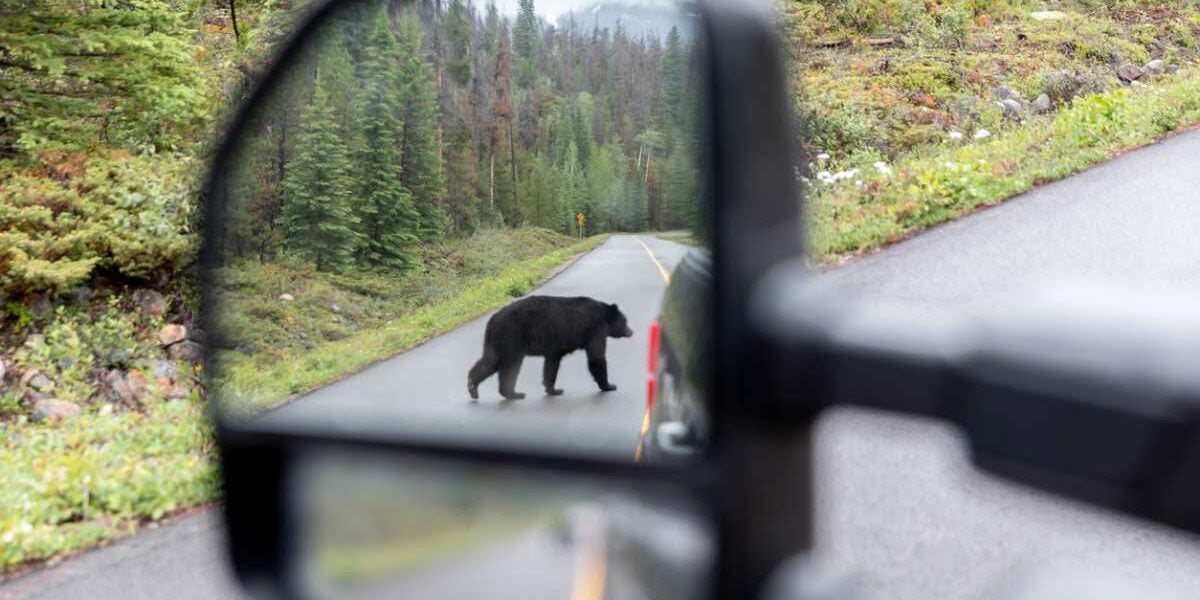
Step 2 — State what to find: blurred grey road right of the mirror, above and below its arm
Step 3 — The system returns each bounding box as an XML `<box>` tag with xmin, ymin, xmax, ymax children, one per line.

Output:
<box><xmin>818</xmin><ymin>127</ymin><xmax>1200</xmax><ymax>600</ymax></box>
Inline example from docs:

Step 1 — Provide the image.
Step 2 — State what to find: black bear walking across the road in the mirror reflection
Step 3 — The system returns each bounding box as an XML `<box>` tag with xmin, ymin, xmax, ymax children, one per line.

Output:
<box><xmin>467</xmin><ymin>296</ymin><xmax>634</xmax><ymax>400</ymax></box>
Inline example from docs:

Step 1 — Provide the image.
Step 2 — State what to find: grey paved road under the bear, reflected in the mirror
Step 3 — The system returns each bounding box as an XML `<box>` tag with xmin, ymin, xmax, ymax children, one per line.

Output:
<box><xmin>266</xmin><ymin>235</ymin><xmax>686</xmax><ymax>460</ymax></box>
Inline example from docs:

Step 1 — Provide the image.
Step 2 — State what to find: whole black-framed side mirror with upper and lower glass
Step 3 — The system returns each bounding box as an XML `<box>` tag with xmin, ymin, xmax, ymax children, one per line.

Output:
<box><xmin>202</xmin><ymin>0</ymin><xmax>809</xmax><ymax>598</ymax></box>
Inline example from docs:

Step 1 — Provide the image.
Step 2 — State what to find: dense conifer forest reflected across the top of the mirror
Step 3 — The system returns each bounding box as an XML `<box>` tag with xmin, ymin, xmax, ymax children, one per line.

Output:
<box><xmin>228</xmin><ymin>0</ymin><xmax>701</xmax><ymax>270</ymax></box>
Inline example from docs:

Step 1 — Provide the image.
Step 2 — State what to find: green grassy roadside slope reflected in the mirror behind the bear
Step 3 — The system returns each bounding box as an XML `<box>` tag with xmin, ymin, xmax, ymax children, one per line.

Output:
<box><xmin>215</xmin><ymin>229</ymin><xmax>606</xmax><ymax>412</ymax></box>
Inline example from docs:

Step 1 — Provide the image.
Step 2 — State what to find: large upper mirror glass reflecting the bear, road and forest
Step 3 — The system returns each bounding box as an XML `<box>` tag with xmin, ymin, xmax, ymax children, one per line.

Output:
<box><xmin>204</xmin><ymin>0</ymin><xmax>707</xmax><ymax>460</ymax></box>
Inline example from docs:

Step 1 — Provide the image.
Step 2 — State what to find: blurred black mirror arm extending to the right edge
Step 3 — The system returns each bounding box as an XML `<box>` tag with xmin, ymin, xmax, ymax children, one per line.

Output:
<box><xmin>755</xmin><ymin>262</ymin><xmax>1200</xmax><ymax>532</ymax></box>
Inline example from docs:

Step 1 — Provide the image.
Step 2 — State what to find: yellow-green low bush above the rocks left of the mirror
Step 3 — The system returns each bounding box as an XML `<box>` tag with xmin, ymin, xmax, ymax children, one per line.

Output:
<box><xmin>0</xmin><ymin>154</ymin><xmax>196</xmax><ymax>298</ymax></box>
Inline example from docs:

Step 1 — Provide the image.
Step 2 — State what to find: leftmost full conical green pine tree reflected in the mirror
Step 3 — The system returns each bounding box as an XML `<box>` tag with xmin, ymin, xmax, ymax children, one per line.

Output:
<box><xmin>278</xmin><ymin>74</ymin><xmax>359</xmax><ymax>271</ymax></box>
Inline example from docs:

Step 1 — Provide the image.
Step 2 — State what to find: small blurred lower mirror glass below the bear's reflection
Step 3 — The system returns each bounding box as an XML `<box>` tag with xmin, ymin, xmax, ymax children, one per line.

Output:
<box><xmin>287</xmin><ymin>451</ymin><xmax>715</xmax><ymax>600</ymax></box>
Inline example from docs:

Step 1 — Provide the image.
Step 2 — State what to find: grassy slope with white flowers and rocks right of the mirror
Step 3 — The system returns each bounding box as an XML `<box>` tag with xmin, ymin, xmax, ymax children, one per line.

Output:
<box><xmin>785</xmin><ymin>0</ymin><xmax>1200</xmax><ymax>260</ymax></box>
